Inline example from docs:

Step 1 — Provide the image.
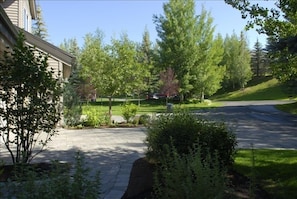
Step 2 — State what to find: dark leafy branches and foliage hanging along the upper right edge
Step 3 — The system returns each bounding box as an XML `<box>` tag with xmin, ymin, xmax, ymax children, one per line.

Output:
<box><xmin>225</xmin><ymin>0</ymin><xmax>297</xmax><ymax>90</ymax></box>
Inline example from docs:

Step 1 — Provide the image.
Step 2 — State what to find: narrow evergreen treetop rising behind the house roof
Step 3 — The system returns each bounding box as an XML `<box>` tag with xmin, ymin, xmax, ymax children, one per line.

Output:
<box><xmin>32</xmin><ymin>6</ymin><xmax>48</xmax><ymax>40</ymax></box>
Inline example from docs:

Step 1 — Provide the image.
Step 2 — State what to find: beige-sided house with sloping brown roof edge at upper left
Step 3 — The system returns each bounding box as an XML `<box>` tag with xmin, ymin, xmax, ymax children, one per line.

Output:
<box><xmin>0</xmin><ymin>0</ymin><xmax>75</xmax><ymax>80</ymax></box>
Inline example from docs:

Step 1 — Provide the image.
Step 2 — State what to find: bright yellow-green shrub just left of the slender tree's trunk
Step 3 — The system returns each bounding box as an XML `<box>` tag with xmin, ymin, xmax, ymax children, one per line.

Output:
<box><xmin>82</xmin><ymin>106</ymin><xmax>109</xmax><ymax>127</ymax></box>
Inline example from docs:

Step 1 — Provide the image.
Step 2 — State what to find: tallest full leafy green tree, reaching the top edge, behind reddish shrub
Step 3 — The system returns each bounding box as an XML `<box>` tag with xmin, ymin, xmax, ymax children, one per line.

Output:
<box><xmin>154</xmin><ymin>0</ymin><xmax>199</xmax><ymax>100</ymax></box>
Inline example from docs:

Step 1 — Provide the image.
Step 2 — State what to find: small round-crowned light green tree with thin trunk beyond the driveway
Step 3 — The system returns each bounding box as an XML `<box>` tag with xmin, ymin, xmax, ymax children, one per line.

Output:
<box><xmin>80</xmin><ymin>31</ymin><xmax>147</xmax><ymax>119</ymax></box>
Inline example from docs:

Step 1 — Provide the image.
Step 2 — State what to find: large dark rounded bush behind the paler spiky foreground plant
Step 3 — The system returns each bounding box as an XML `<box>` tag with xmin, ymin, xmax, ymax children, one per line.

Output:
<box><xmin>146</xmin><ymin>111</ymin><xmax>236</xmax><ymax>166</ymax></box>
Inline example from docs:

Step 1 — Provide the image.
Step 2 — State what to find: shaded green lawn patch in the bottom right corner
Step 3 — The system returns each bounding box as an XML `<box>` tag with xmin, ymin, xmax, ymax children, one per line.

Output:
<box><xmin>235</xmin><ymin>149</ymin><xmax>297</xmax><ymax>199</ymax></box>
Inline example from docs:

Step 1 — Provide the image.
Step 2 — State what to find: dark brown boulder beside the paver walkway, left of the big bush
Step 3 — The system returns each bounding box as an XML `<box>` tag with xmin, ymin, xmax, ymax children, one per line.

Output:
<box><xmin>122</xmin><ymin>158</ymin><xmax>155</xmax><ymax>199</ymax></box>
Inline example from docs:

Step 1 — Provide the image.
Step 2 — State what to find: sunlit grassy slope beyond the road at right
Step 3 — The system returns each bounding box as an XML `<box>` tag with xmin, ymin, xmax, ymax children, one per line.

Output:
<box><xmin>212</xmin><ymin>77</ymin><xmax>291</xmax><ymax>101</ymax></box>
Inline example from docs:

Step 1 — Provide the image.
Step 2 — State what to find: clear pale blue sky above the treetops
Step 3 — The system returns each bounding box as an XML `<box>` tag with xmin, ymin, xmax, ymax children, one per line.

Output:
<box><xmin>37</xmin><ymin>0</ymin><xmax>273</xmax><ymax>48</ymax></box>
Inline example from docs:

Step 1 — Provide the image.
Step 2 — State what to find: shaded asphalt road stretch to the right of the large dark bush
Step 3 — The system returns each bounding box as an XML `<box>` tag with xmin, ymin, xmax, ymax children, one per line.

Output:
<box><xmin>198</xmin><ymin>101</ymin><xmax>297</xmax><ymax>149</ymax></box>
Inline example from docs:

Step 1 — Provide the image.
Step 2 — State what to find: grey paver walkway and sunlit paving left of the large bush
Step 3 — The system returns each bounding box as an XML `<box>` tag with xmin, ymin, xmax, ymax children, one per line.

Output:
<box><xmin>0</xmin><ymin>128</ymin><xmax>146</xmax><ymax>199</ymax></box>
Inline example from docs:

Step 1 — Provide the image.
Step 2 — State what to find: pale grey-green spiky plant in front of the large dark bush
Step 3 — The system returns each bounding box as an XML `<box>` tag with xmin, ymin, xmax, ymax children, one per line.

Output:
<box><xmin>153</xmin><ymin>147</ymin><xmax>226</xmax><ymax>199</ymax></box>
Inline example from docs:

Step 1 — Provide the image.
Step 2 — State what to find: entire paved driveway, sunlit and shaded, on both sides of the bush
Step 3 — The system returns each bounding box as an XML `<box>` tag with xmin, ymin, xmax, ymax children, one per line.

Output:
<box><xmin>0</xmin><ymin>101</ymin><xmax>297</xmax><ymax>199</ymax></box>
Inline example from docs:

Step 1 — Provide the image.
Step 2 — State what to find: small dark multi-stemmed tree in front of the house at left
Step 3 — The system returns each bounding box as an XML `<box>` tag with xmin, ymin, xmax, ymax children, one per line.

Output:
<box><xmin>0</xmin><ymin>33</ymin><xmax>62</xmax><ymax>164</ymax></box>
